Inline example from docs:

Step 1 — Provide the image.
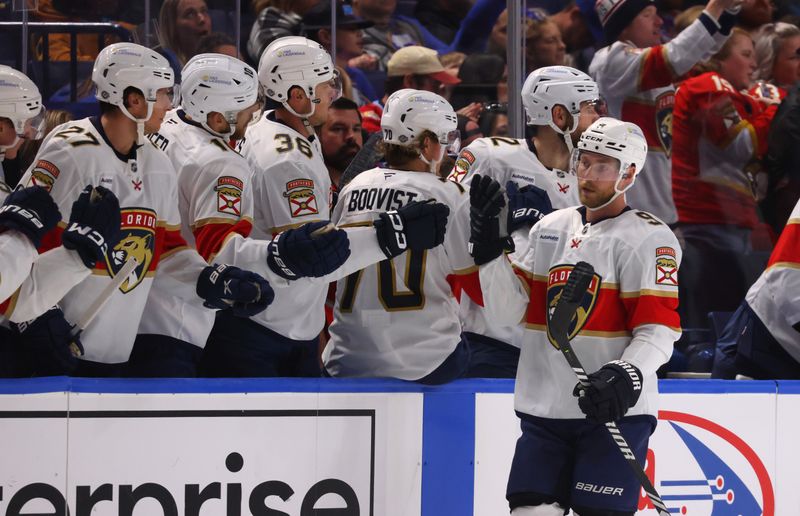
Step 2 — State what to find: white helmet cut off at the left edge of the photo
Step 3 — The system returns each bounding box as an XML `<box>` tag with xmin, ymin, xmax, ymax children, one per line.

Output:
<box><xmin>0</xmin><ymin>65</ymin><xmax>45</xmax><ymax>145</ymax></box>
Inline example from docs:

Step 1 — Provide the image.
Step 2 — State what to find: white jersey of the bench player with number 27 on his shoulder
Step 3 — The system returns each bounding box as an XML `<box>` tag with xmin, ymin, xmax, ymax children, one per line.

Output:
<box><xmin>11</xmin><ymin>118</ymin><xmax>205</xmax><ymax>363</ymax></box>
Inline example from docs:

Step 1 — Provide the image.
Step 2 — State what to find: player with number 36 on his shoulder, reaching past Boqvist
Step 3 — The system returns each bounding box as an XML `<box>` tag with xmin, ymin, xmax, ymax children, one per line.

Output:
<box><xmin>203</xmin><ymin>36</ymin><xmax>447</xmax><ymax>376</ymax></box>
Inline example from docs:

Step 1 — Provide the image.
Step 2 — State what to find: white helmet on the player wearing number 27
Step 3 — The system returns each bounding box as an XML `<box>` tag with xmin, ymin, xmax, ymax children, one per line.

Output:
<box><xmin>92</xmin><ymin>43</ymin><xmax>175</xmax><ymax>125</ymax></box>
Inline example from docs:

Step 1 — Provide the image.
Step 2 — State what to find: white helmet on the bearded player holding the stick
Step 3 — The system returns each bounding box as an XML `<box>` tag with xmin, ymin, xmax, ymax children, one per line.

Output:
<box><xmin>572</xmin><ymin>117</ymin><xmax>647</xmax><ymax>209</ymax></box>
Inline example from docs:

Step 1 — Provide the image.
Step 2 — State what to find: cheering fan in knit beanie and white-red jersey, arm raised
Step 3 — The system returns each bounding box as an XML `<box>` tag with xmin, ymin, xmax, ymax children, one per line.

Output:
<box><xmin>589</xmin><ymin>0</ymin><xmax>741</xmax><ymax>224</ymax></box>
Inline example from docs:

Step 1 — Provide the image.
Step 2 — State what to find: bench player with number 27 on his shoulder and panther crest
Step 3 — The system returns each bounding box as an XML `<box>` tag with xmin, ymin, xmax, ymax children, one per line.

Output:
<box><xmin>10</xmin><ymin>43</ymin><xmax>269</xmax><ymax>376</ymax></box>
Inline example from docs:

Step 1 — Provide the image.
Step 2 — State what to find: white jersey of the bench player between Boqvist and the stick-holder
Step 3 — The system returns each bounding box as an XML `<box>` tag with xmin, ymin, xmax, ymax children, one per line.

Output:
<box><xmin>448</xmin><ymin>137</ymin><xmax>580</xmax><ymax>347</ymax></box>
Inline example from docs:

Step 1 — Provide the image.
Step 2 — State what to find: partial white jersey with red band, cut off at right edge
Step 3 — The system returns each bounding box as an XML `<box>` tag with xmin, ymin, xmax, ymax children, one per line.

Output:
<box><xmin>745</xmin><ymin>202</ymin><xmax>800</xmax><ymax>362</ymax></box>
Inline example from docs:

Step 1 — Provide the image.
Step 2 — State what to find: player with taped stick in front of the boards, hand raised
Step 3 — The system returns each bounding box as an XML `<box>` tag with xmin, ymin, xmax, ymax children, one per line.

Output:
<box><xmin>470</xmin><ymin>118</ymin><xmax>681</xmax><ymax>516</ymax></box>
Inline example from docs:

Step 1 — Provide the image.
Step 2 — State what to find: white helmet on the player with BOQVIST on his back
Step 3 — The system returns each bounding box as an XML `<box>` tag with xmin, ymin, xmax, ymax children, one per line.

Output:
<box><xmin>381</xmin><ymin>88</ymin><xmax>460</xmax><ymax>154</ymax></box>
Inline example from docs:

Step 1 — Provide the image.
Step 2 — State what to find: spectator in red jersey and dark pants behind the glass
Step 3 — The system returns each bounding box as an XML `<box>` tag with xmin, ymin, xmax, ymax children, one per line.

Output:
<box><xmin>672</xmin><ymin>29</ymin><xmax>775</xmax><ymax>327</ymax></box>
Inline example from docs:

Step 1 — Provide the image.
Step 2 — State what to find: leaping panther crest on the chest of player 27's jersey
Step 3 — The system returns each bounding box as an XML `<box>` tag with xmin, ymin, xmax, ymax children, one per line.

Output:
<box><xmin>106</xmin><ymin>208</ymin><xmax>157</xmax><ymax>293</ymax></box>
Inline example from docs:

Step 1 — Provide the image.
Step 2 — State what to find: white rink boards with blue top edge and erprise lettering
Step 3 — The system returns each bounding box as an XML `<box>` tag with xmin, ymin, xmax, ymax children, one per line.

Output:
<box><xmin>0</xmin><ymin>378</ymin><xmax>800</xmax><ymax>516</ymax></box>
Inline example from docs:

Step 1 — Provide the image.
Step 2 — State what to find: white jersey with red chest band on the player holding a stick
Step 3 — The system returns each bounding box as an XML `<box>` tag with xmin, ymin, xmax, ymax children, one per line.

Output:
<box><xmin>480</xmin><ymin>207</ymin><xmax>681</xmax><ymax>418</ymax></box>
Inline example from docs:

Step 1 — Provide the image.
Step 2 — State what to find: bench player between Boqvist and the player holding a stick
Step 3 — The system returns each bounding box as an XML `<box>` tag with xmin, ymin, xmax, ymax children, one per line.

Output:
<box><xmin>449</xmin><ymin>66</ymin><xmax>604</xmax><ymax>378</ymax></box>
